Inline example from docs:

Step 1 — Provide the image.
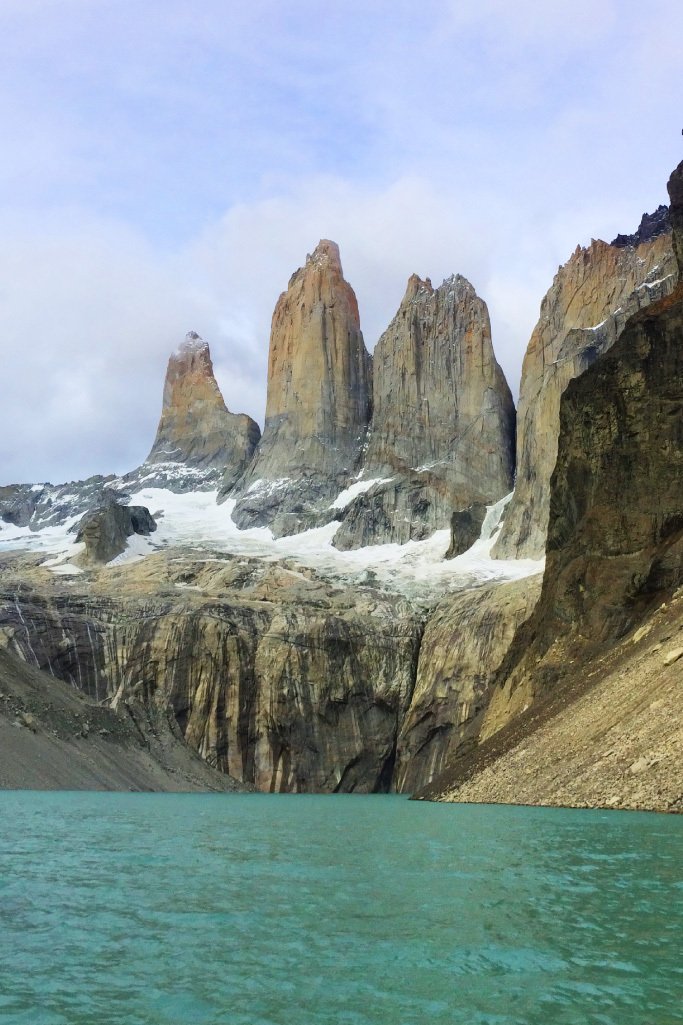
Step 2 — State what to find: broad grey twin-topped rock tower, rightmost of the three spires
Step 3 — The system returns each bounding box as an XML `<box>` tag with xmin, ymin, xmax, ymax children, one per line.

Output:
<box><xmin>334</xmin><ymin>275</ymin><xmax>515</xmax><ymax>548</ymax></box>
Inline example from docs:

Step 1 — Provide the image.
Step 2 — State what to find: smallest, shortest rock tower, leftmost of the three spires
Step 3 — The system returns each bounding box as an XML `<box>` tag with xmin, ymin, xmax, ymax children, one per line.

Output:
<box><xmin>147</xmin><ymin>331</ymin><xmax>260</xmax><ymax>483</ymax></box>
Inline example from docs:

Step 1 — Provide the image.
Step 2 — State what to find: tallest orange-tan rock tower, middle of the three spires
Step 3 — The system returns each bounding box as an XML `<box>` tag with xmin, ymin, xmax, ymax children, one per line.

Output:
<box><xmin>229</xmin><ymin>240</ymin><xmax>372</xmax><ymax>534</ymax></box>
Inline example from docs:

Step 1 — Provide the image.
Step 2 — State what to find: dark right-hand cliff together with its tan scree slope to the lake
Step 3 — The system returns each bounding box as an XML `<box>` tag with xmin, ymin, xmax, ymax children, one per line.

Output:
<box><xmin>420</xmin><ymin>163</ymin><xmax>683</xmax><ymax>808</ymax></box>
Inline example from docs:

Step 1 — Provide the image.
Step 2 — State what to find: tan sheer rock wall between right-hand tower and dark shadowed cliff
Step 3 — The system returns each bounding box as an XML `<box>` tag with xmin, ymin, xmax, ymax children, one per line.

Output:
<box><xmin>493</xmin><ymin>225</ymin><xmax>677</xmax><ymax>559</ymax></box>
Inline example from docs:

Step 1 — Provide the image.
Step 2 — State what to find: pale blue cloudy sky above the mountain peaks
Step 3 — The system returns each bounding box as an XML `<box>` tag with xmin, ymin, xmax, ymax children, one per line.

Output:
<box><xmin>0</xmin><ymin>0</ymin><xmax>683</xmax><ymax>484</ymax></box>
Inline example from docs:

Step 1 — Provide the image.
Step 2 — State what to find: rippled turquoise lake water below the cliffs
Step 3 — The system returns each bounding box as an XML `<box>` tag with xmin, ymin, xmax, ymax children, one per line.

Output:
<box><xmin>0</xmin><ymin>792</ymin><xmax>683</xmax><ymax>1025</ymax></box>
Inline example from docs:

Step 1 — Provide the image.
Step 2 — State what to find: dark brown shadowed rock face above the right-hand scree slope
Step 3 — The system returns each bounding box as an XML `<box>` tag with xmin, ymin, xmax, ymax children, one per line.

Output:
<box><xmin>475</xmin><ymin>163</ymin><xmax>683</xmax><ymax>735</ymax></box>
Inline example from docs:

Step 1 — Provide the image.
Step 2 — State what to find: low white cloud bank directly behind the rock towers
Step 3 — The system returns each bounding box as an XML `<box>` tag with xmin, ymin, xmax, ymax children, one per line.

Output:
<box><xmin>0</xmin><ymin>176</ymin><xmax>566</xmax><ymax>481</ymax></box>
